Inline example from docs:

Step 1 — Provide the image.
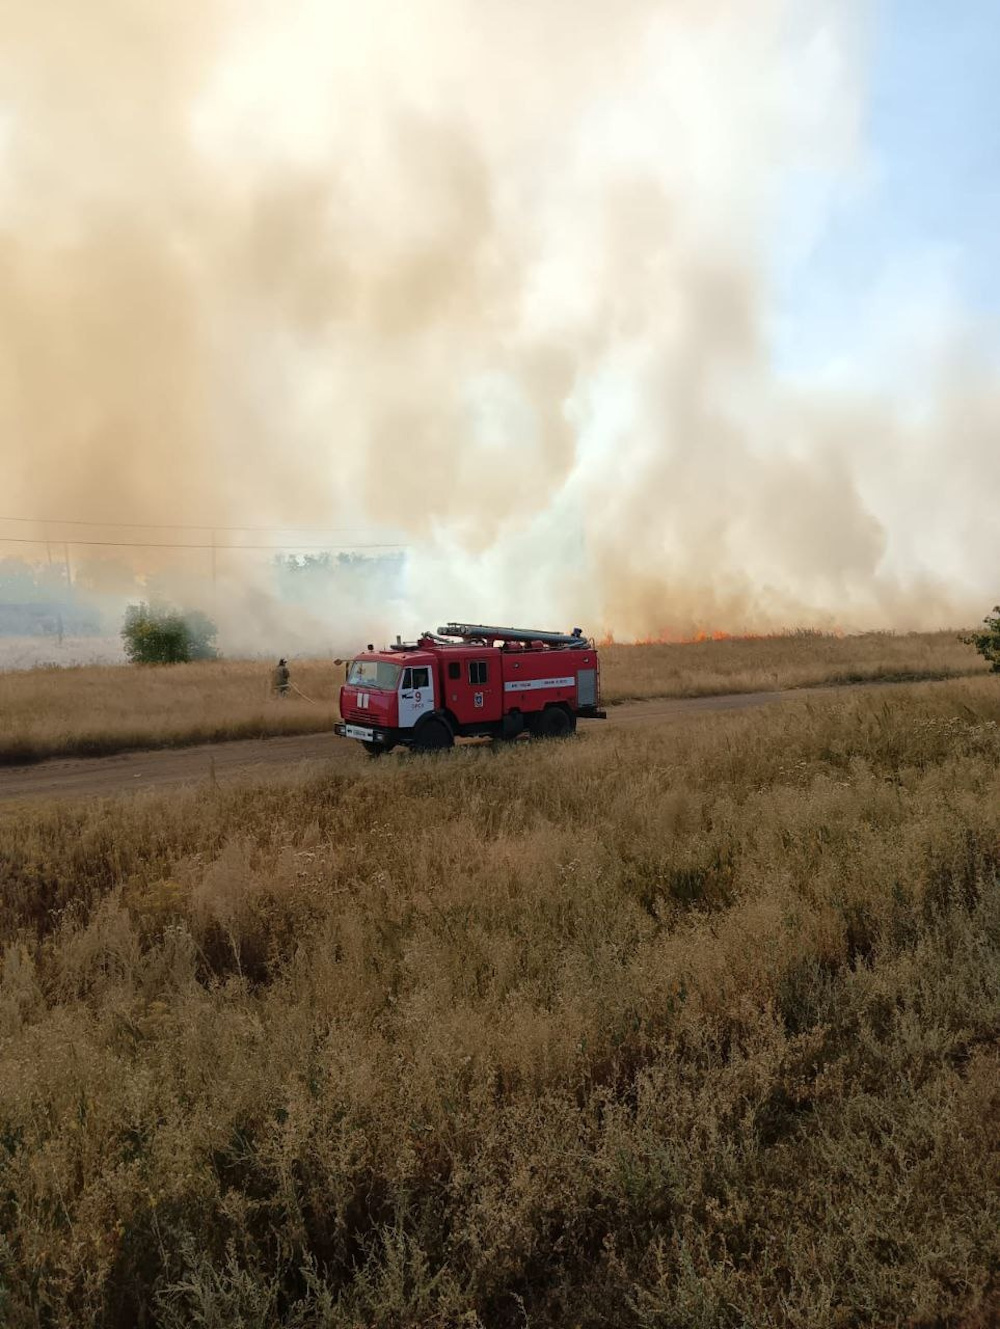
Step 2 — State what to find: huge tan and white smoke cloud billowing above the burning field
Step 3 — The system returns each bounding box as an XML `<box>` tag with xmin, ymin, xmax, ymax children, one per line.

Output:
<box><xmin>0</xmin><ymin>0</ymin><xmax>1000</xmax><ymax>650</ymax></box>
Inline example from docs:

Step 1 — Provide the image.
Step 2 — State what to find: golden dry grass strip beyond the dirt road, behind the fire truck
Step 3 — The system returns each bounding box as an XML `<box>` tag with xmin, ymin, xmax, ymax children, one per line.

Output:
<box><xmin>0</xmin><ymin>633</ymin><xmax>985</xmax><ymax>763</ymax></box>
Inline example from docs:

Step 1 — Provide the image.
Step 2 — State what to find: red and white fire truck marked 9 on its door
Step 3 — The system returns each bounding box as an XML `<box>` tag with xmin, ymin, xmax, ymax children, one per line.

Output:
<box><xmin>335</xmin><ymin>623</ymin><xmax>605</xmax><ymax>756</ymax></box>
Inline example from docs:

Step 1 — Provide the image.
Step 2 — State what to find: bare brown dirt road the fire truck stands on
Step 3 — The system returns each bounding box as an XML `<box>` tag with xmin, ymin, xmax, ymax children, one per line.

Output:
<box><xmin>0</xmin><ymin>688</ymin><xmax>797</xmax><ymax>803</ymax></box>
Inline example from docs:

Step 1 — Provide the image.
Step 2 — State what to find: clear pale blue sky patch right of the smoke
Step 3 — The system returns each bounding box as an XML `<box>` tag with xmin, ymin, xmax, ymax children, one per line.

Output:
<box><xmin>774</xmin><ymin>0</ymin><xmax>1000</xmax><ymax>375</ymax></box>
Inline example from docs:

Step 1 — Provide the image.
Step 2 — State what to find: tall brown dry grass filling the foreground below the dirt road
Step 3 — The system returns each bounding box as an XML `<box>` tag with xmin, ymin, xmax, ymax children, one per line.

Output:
<box><xmin>0</xmin><ymin>679</ymin><xmax>1000</xmax><ymax>1329</ymax></box>
